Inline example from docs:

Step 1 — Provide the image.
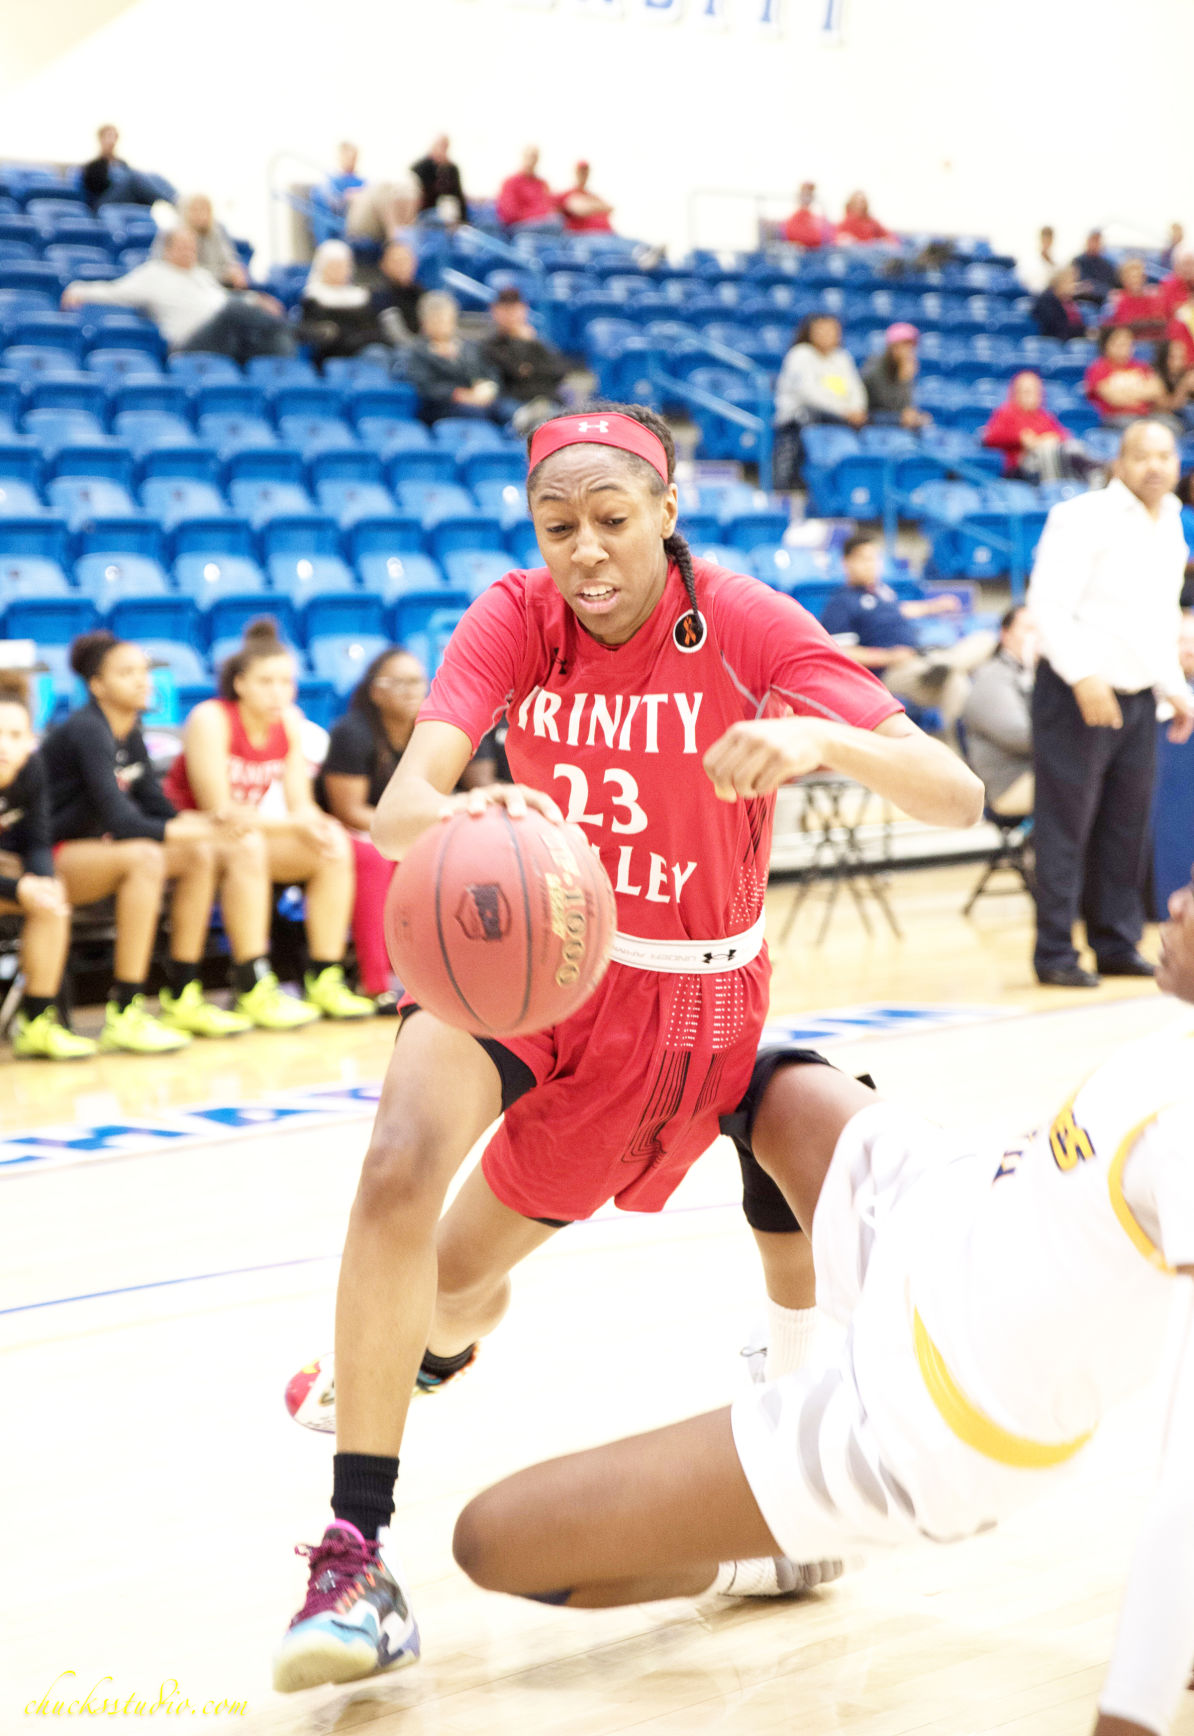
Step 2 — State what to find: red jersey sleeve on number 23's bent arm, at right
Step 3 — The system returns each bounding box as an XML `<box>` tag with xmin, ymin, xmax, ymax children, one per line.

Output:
<box><xmin>717</xmin><ymin>578</ymin><xmax>904</xmax><ymax>729</ymax></box>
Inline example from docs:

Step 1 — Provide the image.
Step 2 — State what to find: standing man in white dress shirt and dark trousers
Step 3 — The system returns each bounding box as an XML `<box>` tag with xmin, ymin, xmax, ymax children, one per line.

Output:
<box><xmin>1027</xmin><ymin>418</ymin><xmax>1194</xmax><ymax>988</ymax></box>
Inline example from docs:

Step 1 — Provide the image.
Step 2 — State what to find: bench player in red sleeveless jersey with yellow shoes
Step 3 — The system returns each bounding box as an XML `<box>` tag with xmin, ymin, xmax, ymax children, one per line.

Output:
<box><xmin>167</xmin><ymin>618</ymin><xmax>375</xmax><ymax>1019</ymax></box>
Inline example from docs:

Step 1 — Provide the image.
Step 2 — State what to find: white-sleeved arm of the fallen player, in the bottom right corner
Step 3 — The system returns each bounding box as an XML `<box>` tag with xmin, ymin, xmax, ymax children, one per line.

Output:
<box><xmin>1099</xmin><ymin>1278</ymin><xmax>1194</xmax><ymax>1733</ymax></box>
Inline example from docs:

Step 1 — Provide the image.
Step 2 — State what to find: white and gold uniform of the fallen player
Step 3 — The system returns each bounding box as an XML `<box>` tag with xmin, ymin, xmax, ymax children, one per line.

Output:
<box><xmin>732</xmin><ymin>1021</ymin><xmax>1194</xmax><ymax>1731</ymax></box>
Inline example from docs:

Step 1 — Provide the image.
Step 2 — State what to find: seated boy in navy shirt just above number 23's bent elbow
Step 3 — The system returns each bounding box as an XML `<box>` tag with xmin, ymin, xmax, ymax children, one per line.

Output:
<box><xmin>821</xmin><ymin>531</ymin><xmax>996</xmax><ymax>731</ymax></box>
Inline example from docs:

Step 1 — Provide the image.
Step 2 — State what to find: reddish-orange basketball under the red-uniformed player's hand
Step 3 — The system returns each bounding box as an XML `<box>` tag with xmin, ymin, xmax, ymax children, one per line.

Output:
<box><xmin>385</xmin><ymin>804</ymin><xmax>614</xmax><ymax>1036</ymax></box>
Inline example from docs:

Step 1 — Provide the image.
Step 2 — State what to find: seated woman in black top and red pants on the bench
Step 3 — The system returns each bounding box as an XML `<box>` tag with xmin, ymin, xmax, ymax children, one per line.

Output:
<box><xmin>316</xmin><ymin>646</ymin><xmax>495</xmax><ymax>1014</ymax></box>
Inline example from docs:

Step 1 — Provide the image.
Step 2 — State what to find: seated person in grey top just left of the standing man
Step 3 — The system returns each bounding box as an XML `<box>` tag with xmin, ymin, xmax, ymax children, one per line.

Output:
<box><xmin>961</xmin><ymin>602</ymin><xmax>1036</xmax><ymax>814</ymax></box>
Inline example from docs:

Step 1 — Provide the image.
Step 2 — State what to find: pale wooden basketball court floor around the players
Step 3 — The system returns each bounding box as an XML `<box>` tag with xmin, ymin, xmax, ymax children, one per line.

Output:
<box><xmin>0</xmin><ymin>868</ymin><xmax>1194</xmax><ymax>1736</ymax></box>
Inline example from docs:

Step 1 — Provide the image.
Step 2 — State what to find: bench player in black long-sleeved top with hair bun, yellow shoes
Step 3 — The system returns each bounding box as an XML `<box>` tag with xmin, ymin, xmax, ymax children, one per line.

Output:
<box><xmin>42</xmin><ymin>632</ymin><xmax>303</xmax><ymax>1054</ymax></box>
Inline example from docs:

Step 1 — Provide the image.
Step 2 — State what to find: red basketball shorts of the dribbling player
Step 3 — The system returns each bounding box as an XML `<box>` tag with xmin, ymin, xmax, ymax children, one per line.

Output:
<box><xmin>482</xmin><ymin>951</ymin><xmax>771</xmax><ymax>1222</ymax></box>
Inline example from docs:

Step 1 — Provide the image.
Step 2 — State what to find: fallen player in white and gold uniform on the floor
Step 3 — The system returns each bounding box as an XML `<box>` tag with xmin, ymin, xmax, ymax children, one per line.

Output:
<box><xmin>455</xmin><ymin>885</ymin><xmax>1194</xmax><ymax>1736</ymax></box>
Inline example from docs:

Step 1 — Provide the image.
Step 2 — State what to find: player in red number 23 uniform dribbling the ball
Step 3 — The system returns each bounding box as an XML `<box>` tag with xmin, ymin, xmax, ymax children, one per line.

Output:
<box><xmin>274</xmin><ymin>406</ymin><xmax>982</xmax><ymax>1691</ymax></box>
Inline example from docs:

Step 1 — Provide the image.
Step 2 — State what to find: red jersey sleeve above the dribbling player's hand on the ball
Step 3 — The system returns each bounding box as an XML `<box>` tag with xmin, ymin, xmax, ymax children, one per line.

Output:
<box><xmin>418</xmin><ymin>573</ymin><xmax>526</xmax><ymax>753</ymax></box>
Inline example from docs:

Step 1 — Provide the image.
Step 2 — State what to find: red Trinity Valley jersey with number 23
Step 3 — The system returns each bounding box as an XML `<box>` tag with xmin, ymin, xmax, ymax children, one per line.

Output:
<box><xmin>420</xmin><ymin>561</ymin><xmax>901</xmax><ymax>941</ymax></box>
